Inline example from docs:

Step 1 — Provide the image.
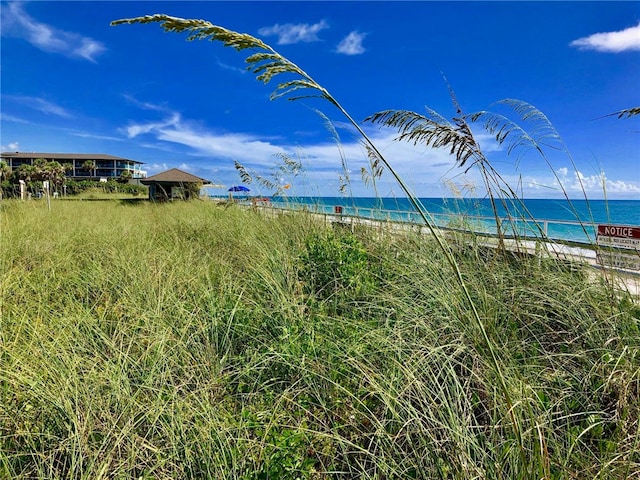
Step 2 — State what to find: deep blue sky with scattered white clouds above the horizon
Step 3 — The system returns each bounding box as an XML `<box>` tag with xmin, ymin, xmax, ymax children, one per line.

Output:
<box><xmin>0</xmin><ymin>1</ymin><xmax>640</xmax><ymax>199</ymax></box>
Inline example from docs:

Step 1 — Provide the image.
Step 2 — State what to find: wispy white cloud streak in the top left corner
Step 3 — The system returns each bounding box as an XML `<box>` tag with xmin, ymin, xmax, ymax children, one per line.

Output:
<box><xmin>0</xmin><ymin>2</ymin><xmax>106</xmax><ymax>63</ymax></box>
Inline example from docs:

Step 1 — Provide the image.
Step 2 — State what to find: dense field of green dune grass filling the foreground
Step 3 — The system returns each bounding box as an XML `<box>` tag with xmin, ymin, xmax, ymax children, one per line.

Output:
<box><xmin>0</xmin><ymin>201</ymin><xmax>640</xmax><ymax>479</ymax></box>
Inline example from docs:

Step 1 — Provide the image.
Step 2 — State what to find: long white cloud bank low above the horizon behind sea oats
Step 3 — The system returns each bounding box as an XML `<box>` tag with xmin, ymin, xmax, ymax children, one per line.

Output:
<box><xmin>124</xmin><ymin>106</ymin><xmax>640</xmax><ymax>198</ymax></box>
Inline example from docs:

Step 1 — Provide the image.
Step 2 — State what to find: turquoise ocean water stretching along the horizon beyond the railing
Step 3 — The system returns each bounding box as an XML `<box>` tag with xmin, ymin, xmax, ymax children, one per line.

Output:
<box><xmin>262</xmin><ymin>197</ymin><xmax>640</xmax><ymax>243</ymax></box>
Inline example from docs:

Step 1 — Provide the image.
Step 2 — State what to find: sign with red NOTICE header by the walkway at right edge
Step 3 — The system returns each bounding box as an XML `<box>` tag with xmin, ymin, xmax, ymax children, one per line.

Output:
<box><xmin>596</xmin><ymin>225</ymin><xmax>640</xmax><ymax>270</ymax></box>
